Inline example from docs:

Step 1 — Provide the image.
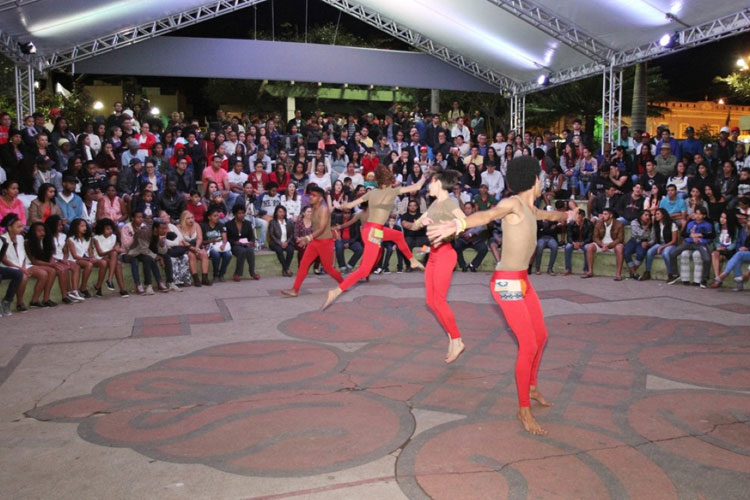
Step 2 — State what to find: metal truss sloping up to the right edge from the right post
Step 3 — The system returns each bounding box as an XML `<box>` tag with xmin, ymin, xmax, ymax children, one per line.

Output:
<box><xmin>519</xmin><ymin>9</ymin><xmax>750</xmax><ymax>93</ymax></box>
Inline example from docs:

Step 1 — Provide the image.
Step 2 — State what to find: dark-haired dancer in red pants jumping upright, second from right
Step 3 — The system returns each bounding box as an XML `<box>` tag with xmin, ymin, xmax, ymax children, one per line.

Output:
<box><xmin>415</xmin><ymin>170</ymin><xmax>464</xmax><ymax>363</ymax></box>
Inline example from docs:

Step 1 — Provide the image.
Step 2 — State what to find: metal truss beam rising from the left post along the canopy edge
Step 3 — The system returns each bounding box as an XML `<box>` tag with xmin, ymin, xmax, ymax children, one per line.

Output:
<box><xmin>39</xmin><ymin>0</ymin><xmax>265</xmax><ymax>70</ymax></box>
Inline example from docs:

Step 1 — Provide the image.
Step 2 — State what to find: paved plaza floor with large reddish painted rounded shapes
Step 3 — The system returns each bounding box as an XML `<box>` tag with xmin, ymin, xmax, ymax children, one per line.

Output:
<box><xmin>0</xmin><ymin>273</ymin><xmax>750</xmax><ymax>500</ymax></box>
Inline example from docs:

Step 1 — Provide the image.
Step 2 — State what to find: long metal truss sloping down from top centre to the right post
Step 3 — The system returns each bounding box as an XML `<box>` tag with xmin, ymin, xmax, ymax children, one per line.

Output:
<box><xmin>322</xmin><ymin>0</ymin><xmax>518</xmax><ymax>90</ymax></box>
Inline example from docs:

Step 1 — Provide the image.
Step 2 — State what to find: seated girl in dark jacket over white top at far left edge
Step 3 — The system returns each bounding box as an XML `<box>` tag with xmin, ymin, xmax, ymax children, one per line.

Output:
<box><xmin>0</xmin><ymin>212</ymin><xmax>57</xmax><ymax>312</ymax></box>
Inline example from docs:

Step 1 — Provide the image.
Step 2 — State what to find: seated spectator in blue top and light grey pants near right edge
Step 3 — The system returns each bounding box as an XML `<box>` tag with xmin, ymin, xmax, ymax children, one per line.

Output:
<box><xmin>668</xmin><ymin>207</ymin><xmax>714</xmax><ymax>288</ymax></box>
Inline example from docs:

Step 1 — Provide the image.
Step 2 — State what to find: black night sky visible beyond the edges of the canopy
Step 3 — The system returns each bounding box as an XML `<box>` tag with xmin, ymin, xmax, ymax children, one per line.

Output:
<box><xmin>169</xmin><ymin>0</ymin><xmax>750</xmax><ymax>102</ymax></box>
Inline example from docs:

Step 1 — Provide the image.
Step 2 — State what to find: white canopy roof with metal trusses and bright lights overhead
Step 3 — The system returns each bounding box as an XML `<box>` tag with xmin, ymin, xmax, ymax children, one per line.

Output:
<box><xmin>0</xmin><ymin>0</ymin><xmax>750</xmax><ymax>93</ymax></box>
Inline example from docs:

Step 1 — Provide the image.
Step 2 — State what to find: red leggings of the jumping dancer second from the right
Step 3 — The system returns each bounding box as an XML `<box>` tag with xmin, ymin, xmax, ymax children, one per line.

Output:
<box><xmin>424</xmin><ymin>243</ymin><xmax>461</xmax><ymax>339</ymax></box>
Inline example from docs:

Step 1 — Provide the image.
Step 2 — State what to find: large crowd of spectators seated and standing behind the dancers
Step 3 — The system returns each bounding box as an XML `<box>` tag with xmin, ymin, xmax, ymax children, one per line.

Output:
<box><xmin>0</xmin><ymin>103</ymin><xmax>750</xmax><ymax>314</ymax></box>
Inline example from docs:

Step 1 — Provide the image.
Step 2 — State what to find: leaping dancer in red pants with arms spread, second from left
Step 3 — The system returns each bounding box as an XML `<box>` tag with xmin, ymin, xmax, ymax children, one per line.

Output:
<box><xmin>322</xmin><ymin>165</ymin><xmax>426</xmax><ymax>309</ymax></box>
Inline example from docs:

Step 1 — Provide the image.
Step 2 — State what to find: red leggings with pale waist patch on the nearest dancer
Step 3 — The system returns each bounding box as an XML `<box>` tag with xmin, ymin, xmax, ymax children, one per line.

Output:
<box><xmin>490</xmin><ymin>270</ymin><xmax>547</xmax><ymax>407</ymax></box>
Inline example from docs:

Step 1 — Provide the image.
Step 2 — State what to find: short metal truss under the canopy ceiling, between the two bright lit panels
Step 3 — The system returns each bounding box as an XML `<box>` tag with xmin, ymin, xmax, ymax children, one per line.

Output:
<box><xmin>487</xmin><ymin>0</ymin><xmax>614</xmax><ymax>63</ymax></box>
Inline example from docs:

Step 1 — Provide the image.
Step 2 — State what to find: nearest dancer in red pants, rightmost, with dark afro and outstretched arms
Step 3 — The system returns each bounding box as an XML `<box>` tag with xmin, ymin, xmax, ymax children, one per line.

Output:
<box><xmin>428</xmin><ymin>156</ymin><xmax>574</xmax><ymax>434</ymax></box>
